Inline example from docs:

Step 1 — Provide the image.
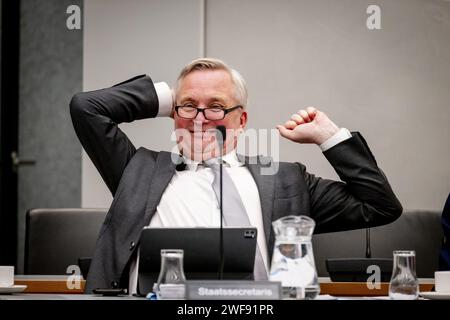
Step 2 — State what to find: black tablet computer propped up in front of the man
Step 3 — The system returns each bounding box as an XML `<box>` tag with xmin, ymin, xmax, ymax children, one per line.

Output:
<box><xmin>138</xmin><ymin>227</ymin><xmax>257</xmax><ymax>295</ymax></box>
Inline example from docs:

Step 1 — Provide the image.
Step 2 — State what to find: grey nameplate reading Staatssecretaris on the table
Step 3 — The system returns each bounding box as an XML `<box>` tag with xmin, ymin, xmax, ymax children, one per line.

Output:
<box><xmin>186</xmin><ymin>280</ymin><xmax>281</xmax><ymax>300</ymax></box>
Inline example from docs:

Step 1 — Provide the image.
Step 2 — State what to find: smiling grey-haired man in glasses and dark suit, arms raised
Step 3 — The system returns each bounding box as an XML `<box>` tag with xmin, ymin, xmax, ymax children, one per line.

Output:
<box><xmin>70</xmin><ymin>59</ymin><xmax>402</xmax><ymax>292</ymax></box>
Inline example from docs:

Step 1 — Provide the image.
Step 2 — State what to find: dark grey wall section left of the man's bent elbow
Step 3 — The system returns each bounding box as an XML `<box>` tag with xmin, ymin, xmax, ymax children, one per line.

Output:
<box><xmin>18</xmin><ymin>0</ymin><xmax>83</xmax><ymax>273</ymax></box>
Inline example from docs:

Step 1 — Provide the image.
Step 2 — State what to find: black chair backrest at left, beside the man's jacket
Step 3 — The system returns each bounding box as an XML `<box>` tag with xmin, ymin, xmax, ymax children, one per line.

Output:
<box><xmin>24</xmin><ymin>208</ymin><xmax>107</xmax><ymax>275</ymax></box>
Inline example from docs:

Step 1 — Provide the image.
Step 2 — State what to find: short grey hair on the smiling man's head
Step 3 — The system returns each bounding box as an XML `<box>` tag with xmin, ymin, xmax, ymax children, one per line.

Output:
<box><xmin>175</xmin><ymin>58</ymin><xmax>248</xmax><ymax>108</ymax></box>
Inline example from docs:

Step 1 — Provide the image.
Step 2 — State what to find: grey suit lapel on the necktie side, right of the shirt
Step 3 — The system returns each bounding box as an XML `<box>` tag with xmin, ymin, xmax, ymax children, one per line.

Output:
<box><xmin>238</xmin><ymin>155</ymin><xmax>275</xmax><ymax>251</ymax></box>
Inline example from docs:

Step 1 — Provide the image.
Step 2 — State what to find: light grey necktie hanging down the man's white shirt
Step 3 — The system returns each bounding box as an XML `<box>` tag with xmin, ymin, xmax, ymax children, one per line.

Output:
<box><xmin>205</xmin><ymin>163</ymin><xmax>267</xmax><ymax>280</ymax></box>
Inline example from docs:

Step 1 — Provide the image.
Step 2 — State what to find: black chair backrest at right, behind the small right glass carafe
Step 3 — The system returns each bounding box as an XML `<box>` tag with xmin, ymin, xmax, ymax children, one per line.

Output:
<box><xmin>313</xmin><ymin>210</ymin><xmax>443</xmax><ymax>278</ymax></box>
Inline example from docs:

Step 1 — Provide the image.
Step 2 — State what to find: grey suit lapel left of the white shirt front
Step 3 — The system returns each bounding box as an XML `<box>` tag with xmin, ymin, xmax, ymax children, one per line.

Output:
<box><xmin>144</xmin><ymin>151</ymin><xmax>178</xmax><ymax>225</ymax></box>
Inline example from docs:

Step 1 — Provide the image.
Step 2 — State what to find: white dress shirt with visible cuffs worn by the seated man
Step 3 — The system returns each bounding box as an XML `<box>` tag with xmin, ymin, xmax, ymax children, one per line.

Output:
<box><xmin>129</xmin><ymin>82</ymin><xmax>351</xmax><ymax>294</ymax></box>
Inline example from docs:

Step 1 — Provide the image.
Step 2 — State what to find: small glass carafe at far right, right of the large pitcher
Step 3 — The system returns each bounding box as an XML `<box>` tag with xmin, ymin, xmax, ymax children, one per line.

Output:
<box><xmin>389</xmin><ymin>250</ymin><xmax>419</xmax><ymax>300</ymax></box>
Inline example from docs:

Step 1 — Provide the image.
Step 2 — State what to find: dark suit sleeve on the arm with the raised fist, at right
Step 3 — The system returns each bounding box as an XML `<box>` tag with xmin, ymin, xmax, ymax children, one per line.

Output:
<box><xmin>300</xmin><ymin>133</ymin><xmax>402</xmax><ymax>233</ymax></box>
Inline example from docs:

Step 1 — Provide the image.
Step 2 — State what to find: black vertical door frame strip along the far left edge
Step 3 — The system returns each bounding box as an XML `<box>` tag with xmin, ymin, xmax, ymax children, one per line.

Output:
<box><xmin>0</xmin><ymin>0</ymin><xmax>20</xmax><ymax>267</ymax></box>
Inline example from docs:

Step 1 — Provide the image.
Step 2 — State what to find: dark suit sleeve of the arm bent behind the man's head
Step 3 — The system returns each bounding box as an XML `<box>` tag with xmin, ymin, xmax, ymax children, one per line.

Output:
<box><xmin>70</xmin><ymin>76</ymin><xmax>159</xmax><ymax>196</ymax></box>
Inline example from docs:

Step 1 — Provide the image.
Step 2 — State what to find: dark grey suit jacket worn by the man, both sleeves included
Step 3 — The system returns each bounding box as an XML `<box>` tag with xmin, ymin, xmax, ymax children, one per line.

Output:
<box><xmin>70</xmin><ymin>76</ymin><xmax>402</xmax><ymax>292</ymax></box>
